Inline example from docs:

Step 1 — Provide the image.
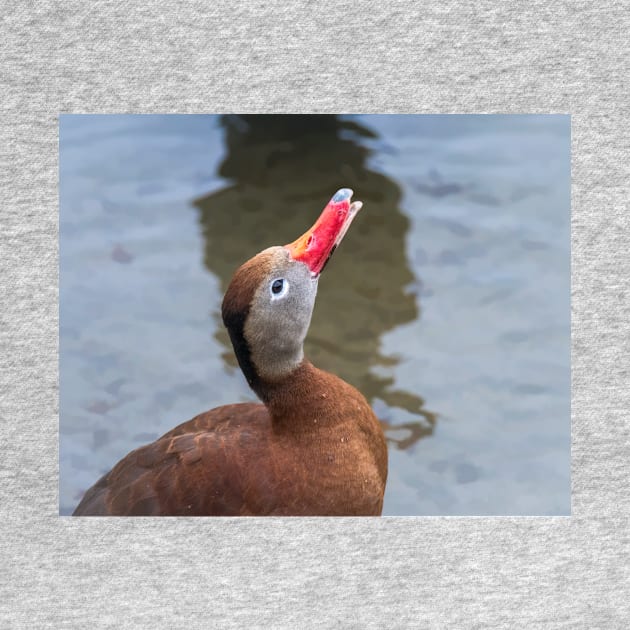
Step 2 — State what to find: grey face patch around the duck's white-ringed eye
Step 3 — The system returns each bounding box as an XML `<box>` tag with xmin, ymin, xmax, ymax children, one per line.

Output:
<box><xmin>243</xmin><ymin>247</ymin><xmax>317</xmax><ymax>380</ymax></box>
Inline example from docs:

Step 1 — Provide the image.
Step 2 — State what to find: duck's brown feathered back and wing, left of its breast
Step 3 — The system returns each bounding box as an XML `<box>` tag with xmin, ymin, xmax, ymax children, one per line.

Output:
<box><xmin>74</xmin><ymin>403</ymin><xmax>270</xmax><ymax>516</ymax></box>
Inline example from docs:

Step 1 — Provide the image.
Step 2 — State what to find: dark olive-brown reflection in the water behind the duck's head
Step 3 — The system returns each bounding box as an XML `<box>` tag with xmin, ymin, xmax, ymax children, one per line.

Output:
<box><xmin>195</xmin><ymin>115</ymin><xmax>435</xmax><ymax>448</ymax></box>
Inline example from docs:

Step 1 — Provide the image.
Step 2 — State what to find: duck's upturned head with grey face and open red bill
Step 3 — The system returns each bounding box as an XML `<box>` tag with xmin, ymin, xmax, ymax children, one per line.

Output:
<box><xmin>222</xmin><ymin>188</ymin><xmax>362</xmax><ymax>389</ymax></box>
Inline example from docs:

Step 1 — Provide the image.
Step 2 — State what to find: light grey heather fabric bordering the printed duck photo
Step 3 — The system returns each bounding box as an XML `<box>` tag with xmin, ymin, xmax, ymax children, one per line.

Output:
<box><xmin>0</xmin><ymin>0</ymin><xmax>630</xmax><ymax>629</ymax></box>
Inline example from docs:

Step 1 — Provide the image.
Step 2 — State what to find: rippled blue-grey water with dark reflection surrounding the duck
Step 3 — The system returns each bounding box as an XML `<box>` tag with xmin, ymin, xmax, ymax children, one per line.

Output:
<box><xmin>60</xmin><ymin>116</ymin><xmax>570</xmax><ymax>515</ymax></box>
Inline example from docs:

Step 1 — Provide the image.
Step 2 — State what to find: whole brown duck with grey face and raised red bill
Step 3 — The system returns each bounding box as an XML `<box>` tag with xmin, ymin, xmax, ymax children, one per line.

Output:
<box><xmin>73</xmin><ymin>188</ymin><xmax>388</xmax><ymax>516</ymax></box>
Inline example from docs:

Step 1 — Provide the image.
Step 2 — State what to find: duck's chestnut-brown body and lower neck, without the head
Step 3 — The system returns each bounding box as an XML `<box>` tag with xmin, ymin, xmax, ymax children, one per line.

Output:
<box><xmin>74</xmin><ymin>361</ymin><xmax>387</xmax><ymax>516</ymax></box>
